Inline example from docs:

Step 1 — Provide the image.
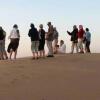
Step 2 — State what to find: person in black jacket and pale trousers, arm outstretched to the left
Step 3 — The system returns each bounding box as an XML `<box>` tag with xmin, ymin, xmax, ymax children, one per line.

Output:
<box><xmin>67</xmin><ymin>25</ymin><xmax>78</xmax><ymax>54</ymax></box>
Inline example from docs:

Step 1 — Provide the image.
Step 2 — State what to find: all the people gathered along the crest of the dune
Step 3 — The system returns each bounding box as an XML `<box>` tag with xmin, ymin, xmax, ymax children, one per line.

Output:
<box><xmin>0</xmin><ymin>22</ymin><xmax>91</xmax><ymax>60</ymax></box>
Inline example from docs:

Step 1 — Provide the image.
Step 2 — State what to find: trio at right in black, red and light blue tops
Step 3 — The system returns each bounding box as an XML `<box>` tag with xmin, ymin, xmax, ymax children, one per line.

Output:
<box><xmin>67</xmin><ymin>25</ymin><xmax>91</xmax><ymax>54</ymax></box>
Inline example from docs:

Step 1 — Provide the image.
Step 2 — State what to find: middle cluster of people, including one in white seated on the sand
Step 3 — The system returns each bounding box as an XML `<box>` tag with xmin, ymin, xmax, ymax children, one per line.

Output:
<box><xmin>28</xmin><ymin>22</ymin><xmax>66</xmax><ymax>59</ymax></box>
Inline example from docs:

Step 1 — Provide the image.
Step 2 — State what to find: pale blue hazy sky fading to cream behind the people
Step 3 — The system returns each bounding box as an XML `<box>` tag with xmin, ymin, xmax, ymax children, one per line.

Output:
<box><xmin>0</xmin><ymin>0</ymin><xmax>100</xmax><ymax>56</ymax></box>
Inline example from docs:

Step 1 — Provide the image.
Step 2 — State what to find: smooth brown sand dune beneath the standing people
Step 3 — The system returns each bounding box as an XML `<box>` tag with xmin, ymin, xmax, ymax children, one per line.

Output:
<box><xmin>0</xmin><ymin>54</ymin><xmax>100</xmax><ymax>100</ymax></box>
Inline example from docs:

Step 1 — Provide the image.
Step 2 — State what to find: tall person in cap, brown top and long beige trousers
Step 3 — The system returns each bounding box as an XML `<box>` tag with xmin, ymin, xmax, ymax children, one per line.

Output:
<box><xmin>46</xmin><ymin>22</ymin><xmax>54</xmax><ymax>57</ymax></box>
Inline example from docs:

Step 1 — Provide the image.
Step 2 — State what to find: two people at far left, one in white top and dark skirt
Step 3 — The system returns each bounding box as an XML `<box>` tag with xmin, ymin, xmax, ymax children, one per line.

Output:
<box><xmin>0</xmin><ymin>24</ymin><xmax>20</xmax><ymax>60</ymax></box>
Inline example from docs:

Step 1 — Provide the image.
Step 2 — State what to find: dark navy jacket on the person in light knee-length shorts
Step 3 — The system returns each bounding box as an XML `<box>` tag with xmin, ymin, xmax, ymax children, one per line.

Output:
<box><xmin>28</xmin><ymin>28</ymin><xmax>39</xmax><ymax>41</ymax></box>
